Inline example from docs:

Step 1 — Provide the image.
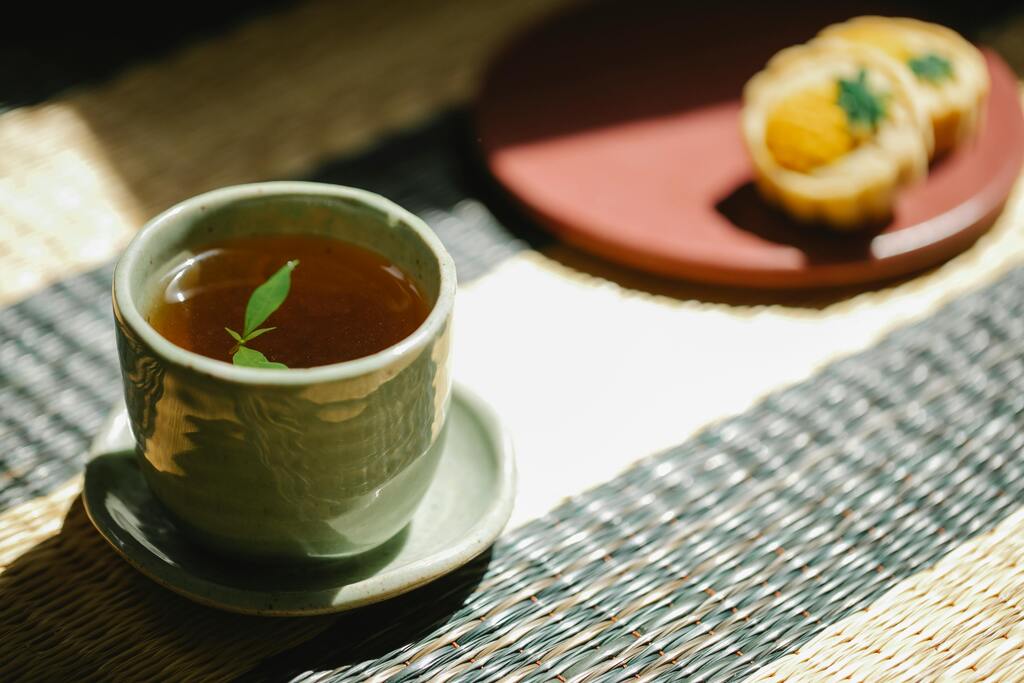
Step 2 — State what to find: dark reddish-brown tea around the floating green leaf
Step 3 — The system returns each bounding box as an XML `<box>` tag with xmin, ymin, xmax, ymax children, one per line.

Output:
<box><xmin>147</xmin><ymin>236</ymin><xmax>430</xmax><ymax>368</ymax></box>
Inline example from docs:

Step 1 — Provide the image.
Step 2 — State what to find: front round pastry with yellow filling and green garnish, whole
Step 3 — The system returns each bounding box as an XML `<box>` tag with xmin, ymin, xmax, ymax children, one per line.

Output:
<box><xmin>741</xmin><ymin>40</ymin><xmax>932</xmax><ymax>230</ymax></box>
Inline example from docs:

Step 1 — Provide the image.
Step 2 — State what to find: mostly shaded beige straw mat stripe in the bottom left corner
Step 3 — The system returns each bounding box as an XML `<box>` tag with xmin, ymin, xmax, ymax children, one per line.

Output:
<box><xmin>0</xmin><ymin>480</ymin><xmax>330</xmax><ymax>681</ymax></box>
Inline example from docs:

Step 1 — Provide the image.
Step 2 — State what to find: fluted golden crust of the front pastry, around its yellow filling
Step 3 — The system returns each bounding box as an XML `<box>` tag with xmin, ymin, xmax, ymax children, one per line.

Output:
<box><xmin>741</xmin><ymin>40</ymin><xmax>932</xmax><ymax>230</ymax></box>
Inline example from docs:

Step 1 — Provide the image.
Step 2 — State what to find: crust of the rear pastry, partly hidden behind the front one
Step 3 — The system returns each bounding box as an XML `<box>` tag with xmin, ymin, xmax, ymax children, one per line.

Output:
<box><xmin>819</xmin><ymin>16</ymin><xmax>989</xmax><ymax>155</ymax></box>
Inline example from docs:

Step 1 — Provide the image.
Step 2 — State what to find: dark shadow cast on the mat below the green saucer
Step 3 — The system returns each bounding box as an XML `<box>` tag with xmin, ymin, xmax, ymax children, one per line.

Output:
<box><xmin>0</xmin><ymin>498</ymin><xmax>489</xmax><ymax>680</ymax></box>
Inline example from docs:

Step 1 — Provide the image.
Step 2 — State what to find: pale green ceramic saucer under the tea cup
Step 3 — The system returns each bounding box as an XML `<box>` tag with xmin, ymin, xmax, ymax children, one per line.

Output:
<box><xmin>82</xmin><ymin>387</ymin><xmax>515</xmax><ymax>615</ymax></box>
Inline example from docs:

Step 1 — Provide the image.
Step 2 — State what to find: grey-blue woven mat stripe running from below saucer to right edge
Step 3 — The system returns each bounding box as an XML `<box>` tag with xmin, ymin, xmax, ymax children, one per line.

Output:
<box><xmin>270</xmin><ymin>270</ymin><xmax>1024</xmax><ymax>681</ymax></box>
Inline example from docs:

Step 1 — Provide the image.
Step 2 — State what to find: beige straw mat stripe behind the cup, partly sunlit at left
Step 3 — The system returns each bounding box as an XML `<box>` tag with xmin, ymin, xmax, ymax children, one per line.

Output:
<box><xmin>0</xmin><ymin>0</ymin><xmax>565</xmax><ymax>303</ymax></box>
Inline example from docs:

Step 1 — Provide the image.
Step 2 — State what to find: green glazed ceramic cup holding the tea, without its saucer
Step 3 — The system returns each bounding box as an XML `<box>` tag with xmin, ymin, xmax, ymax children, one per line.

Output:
<box><xmin>114</xmin><ymin>182</ymin><xmax>456</xmax><ymax>561</ymax></box>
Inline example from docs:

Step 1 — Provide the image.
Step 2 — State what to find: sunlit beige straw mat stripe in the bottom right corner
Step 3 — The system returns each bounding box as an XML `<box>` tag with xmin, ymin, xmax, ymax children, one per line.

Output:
<box><xmin>752</xmin><ymin>511</ymin><xmax>1024</xmax><ymax>683</ymax></box>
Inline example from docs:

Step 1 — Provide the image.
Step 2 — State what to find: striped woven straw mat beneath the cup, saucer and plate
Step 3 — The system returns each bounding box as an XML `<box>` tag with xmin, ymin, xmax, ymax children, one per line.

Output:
<box><xmin>0</xmin><ymin>0</ymin><xmax>1024</xmax><ymax>681</ymax></box>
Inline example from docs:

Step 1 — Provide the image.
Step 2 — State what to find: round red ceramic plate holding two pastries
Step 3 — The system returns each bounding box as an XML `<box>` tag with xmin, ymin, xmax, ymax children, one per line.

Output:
<box><xmin>477</xmin><ymin>3</ymin><xmax>1024</xmax><ymax>288</ymax></box>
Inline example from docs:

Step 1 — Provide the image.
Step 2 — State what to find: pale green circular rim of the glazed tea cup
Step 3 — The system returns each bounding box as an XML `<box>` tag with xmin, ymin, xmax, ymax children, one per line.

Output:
<box><xmin>113</xmin><ymin>180</ymin><xmax>456</xmax><ymax>386</ymax></box>
